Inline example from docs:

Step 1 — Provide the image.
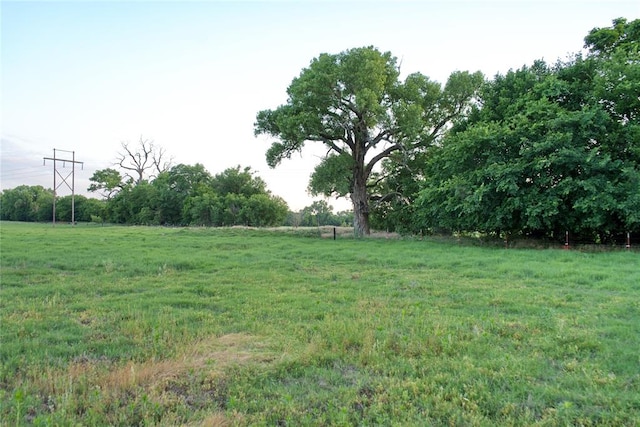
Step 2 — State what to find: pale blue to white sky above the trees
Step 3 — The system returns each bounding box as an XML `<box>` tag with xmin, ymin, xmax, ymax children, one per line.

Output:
<box><xmin>0</xmin><ymin>0</ymin><xmax>640</xmax><ymax>211</ymax></box>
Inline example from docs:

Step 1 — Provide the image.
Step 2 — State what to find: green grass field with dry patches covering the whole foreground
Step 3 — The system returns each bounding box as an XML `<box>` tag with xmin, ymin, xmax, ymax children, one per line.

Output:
<box><xmin>0</xmin><ymin>222</ymin><xmax>640</xmax><ymax>426</ymax></box>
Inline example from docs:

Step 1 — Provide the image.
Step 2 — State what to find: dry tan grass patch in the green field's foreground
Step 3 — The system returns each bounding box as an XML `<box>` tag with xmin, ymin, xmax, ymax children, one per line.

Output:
<box><xmin>31</xmin><ymin>334</ymin><xmax>275</xmax><ymax>425</ymax></box>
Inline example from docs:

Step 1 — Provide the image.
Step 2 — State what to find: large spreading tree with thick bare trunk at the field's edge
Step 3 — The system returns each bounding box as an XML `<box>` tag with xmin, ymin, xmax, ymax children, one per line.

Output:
<box><xmin>255</xmin><ymin>47</ymin><xmax>483</xmax><ymax>236</ymax></box>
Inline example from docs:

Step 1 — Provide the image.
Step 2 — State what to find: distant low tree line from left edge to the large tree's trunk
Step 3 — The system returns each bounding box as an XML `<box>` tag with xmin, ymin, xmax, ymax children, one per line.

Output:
<box><xmin>0</xmin><ymin>159</ymin><xmax>353</xmax><ymax>227</ymax></box>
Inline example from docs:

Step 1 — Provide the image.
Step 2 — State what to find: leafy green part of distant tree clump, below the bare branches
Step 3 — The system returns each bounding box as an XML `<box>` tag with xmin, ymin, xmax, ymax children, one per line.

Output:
<box><xmin>89</xmin><ymin>164</ymin><xmax>288</xmax><ymax>227</ymax></box>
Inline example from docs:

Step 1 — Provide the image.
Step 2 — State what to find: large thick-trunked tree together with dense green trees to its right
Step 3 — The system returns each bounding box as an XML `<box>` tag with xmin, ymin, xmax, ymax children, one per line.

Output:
<box><xmin>255</xmin><ymin>18</ymin><xmax>640</xmax><ymax>242</ymax></box>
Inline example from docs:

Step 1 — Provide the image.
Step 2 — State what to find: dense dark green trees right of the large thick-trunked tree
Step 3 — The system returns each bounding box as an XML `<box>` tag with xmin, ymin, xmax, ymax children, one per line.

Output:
<box><xmin>416</xmin><ymin>21</ymin><xmax>640</xmax><ymax>242</ymax></box>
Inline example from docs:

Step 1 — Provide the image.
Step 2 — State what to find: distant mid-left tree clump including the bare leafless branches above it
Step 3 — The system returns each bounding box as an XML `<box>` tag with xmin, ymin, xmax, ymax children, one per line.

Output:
<box><xmin>88</xmin><ymin>138</ymin><xmax>288</xmax><ymax>226</ymax></box>
